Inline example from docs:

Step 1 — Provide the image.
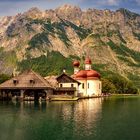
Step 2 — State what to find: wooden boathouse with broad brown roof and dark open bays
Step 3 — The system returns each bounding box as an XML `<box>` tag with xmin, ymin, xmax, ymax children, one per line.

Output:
<box><xmin>0</xmin><ymin>70</ymin><xmax>53</xmax><ymax>100</ymax></box>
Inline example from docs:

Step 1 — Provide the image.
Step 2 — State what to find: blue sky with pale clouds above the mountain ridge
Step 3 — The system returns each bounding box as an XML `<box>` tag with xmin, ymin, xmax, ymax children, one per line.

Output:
<box><xmin>0</xmin><ymin>0</ymin><xmax>140</xmax><ymax>16</ymax></box>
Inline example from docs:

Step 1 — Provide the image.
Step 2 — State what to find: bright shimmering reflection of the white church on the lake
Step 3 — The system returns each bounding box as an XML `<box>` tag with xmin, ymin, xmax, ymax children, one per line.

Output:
<box><xmin>74</xmin><ymin>98</ymin><xmax>102</xmax><ymax>136</ymax></box>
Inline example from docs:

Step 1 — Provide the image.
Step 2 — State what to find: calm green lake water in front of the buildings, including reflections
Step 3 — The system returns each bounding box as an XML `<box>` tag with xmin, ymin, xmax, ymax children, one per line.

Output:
<box><xmin>0</xmin><ymin>96</ymin><xmax>140</xmax><ymax>140</ymax></box>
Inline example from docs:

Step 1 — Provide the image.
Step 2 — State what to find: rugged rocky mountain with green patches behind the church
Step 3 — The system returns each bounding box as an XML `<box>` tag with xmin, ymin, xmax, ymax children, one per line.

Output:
<box><xmin>0</xmin><ymin>5</ymin><xmax>140</xmax><ymax>86</ymax></box>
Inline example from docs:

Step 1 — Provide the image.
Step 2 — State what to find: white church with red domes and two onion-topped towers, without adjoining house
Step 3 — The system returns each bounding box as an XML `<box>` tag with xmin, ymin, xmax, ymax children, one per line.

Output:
<box><xmin>72</xmin><ymin>57</ymin><xmax>102</xmax><ymax>97</ymax></box>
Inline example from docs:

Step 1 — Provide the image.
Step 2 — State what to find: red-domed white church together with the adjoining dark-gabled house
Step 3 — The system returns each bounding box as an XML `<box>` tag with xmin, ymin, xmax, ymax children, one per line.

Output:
<box><xmin>47</xmin><ymin>57</ymin><xmax>102</xmax><ymax>97</ymax></box>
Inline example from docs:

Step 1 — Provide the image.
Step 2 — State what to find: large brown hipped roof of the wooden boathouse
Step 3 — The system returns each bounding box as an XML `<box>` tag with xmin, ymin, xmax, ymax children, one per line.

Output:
<box><xmin>0</xmin><ymin>70</ymin><xmax>52</xmax><ymax>89</ymax></box>
